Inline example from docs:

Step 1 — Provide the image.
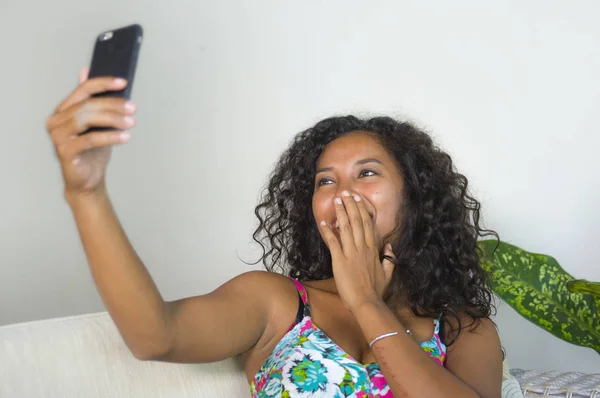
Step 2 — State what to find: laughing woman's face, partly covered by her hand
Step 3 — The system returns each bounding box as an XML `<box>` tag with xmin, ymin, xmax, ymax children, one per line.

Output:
<box><xmin>312</xmin><ymin>132</ymin><xmax>403</xmax><ymax>249</ymax></box>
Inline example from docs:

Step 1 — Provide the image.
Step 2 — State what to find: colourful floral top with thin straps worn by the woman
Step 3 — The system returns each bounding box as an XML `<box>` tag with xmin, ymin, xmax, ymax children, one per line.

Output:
<box><xmin>250</xmin><ymin>278</ymin><xmax>446</xmax><ymax>398</ymax></box>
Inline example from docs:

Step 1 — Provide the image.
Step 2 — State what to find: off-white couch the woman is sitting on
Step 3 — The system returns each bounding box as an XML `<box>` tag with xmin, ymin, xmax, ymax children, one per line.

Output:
<box><xmin>0</xmin><ymin>312</ymin><xmax>523</xmax><ymax>398</ymax></box>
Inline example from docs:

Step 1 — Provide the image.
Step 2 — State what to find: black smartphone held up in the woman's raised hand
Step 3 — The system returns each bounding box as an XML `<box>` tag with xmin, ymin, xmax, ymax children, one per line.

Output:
<box><xmin>83</xmin><ymin>24</ymin><xmax>144</xmax><ymax>134</ymax></box>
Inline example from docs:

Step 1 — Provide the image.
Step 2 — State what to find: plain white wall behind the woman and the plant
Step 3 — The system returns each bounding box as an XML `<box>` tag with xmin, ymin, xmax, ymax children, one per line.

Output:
<box><xmin>0</xmin><ymin>0</ymin><xmax>600</xmax><ymax>372</ymax></box>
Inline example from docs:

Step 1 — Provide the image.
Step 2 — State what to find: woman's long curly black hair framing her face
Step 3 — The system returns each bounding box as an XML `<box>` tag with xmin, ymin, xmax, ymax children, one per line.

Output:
<box><xmin>253</xmin><ymin>116</ymin><xmax>499</xmax><ymax>344</ymax></box>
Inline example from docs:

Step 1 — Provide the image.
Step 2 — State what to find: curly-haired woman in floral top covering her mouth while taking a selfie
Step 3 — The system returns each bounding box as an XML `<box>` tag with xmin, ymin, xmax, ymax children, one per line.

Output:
<box><xmin>47</xmin><ymin>71</ymin><xmax>502</xmax><ymax>398</ymax></box>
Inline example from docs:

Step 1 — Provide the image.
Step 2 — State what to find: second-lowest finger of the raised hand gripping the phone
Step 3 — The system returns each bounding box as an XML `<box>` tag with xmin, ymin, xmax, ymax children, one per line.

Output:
<box><xmin>50</xmin><ymin>111</ymin><xmax>135</xmax><ymax>145</ymax></box>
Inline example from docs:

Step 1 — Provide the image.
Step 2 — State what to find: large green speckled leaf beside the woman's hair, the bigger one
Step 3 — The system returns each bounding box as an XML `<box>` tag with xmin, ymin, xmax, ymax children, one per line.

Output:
<box><xmin>478</xmin><ymin>240</ymin><xmax>600</xmax><ymax>353</ymax></box>
